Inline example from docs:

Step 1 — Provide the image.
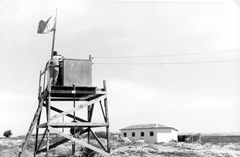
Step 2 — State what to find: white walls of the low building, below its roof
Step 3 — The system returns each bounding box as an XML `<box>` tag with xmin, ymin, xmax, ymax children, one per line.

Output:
<box><xmin>121</xmin><ymin>128</ymin><xmax>178</xmax><ymax>143</ymax></box>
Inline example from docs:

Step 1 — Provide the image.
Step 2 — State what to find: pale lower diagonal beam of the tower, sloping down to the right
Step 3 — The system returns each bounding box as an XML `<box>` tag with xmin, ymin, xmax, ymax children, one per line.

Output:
<box><xmin>48</xmin><ymin>127</ymin><xmax>110</xmax><ymax>156</ymax></box>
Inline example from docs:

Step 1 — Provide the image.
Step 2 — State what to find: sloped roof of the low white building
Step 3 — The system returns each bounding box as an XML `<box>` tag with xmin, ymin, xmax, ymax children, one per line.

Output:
<box><xmin>120</xmin><ymin>124</ymin><xmax>178</xmax><ymax>131</ymax></box>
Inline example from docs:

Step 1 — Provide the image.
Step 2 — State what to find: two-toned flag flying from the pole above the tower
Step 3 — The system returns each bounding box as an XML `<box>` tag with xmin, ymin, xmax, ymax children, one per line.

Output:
<box><xmin>37</xmin><ymin>13</ymin><xmax>57</xmax><ymax>34</ymax></box>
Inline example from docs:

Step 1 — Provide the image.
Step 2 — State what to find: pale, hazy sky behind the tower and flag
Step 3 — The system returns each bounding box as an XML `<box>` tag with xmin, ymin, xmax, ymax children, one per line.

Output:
<box><xmin>0</xmin><ymin>0</ymin><xmax>240</xmax><ymax>136</ymax></box>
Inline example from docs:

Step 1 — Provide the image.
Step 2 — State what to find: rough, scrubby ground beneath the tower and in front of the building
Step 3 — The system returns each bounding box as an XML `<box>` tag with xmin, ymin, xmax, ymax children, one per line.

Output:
<box><xmin>0</xmin><ymin>139</ymin><xmax>240</xmax><ymax>157</ymax></box>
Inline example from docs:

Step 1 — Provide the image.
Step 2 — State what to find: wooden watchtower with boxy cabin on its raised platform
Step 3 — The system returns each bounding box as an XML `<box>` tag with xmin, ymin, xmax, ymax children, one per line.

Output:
<box><xmin>19</xmin><ymin>56</ymin><xmax>110</xmax><ymax>157</ymax></box>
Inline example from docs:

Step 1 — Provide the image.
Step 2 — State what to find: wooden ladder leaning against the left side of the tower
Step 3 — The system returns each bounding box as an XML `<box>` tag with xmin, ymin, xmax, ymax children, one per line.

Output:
<box><xmin>18</xmin><ymin>99</ymin><xmax>44</xmax><ymax>157</ymax></box>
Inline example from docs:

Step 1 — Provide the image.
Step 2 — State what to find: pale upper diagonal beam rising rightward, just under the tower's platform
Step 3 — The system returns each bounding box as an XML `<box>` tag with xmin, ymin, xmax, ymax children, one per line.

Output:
<box><xmin>50</xmin><ymin>95</ymin><xmax>106</xmax><ymax>121</ymax></box>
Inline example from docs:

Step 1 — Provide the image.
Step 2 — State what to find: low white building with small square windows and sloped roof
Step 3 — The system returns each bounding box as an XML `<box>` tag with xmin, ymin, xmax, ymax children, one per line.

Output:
<box><xmin>120</xmin><ymin>124</ymin><xmax>178</xmax><ymax>143</ymax></box>
